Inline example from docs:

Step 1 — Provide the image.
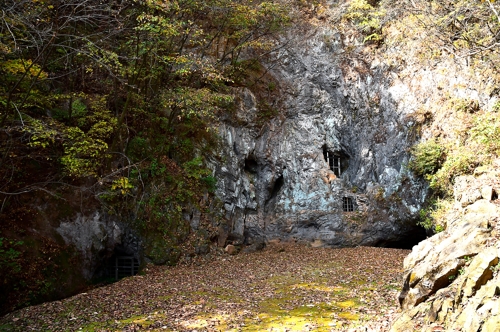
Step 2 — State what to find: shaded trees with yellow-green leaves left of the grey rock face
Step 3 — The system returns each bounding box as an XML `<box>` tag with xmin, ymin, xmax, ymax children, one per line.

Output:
<box><xmin>0</xmin><ymin>0</ymin><xmax>290</xmax><ymax>309</ymax></box>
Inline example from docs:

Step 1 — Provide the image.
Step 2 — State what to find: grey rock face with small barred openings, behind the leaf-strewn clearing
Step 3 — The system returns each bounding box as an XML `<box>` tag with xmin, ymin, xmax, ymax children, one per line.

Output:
<box><xmin>213</xmin><ymin>30</ymin><xmax>426</xmax><ymax>246</ymax></box>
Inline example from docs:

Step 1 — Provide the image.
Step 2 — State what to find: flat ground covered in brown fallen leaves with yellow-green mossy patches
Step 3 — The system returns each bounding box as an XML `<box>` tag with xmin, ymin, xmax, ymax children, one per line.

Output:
<box><xmin>0</xmin><ymin>245</ymin><xmax>408</xmax><ymax>331</ymax></box>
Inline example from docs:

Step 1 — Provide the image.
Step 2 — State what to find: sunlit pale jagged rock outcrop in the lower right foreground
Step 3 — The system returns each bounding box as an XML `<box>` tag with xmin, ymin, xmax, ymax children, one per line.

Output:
<box><xmin>392</xmin><ymin>169</ymin><xmax>500</xmax><ymax>332</ymax></box>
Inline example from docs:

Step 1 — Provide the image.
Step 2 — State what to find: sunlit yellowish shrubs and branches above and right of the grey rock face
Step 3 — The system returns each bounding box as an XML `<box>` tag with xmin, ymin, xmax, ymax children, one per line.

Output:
<box><xmin>332</xmin><ymin>0</ymin><xmax>500</xmax><ymax>231</ymax></box>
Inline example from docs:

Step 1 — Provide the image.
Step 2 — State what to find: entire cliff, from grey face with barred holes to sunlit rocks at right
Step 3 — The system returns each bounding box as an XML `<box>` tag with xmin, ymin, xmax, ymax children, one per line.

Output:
<box><xmin>214</xmin><ymin>4</ymin><xmax>500</xmax><ymax>331</ymax></box>
